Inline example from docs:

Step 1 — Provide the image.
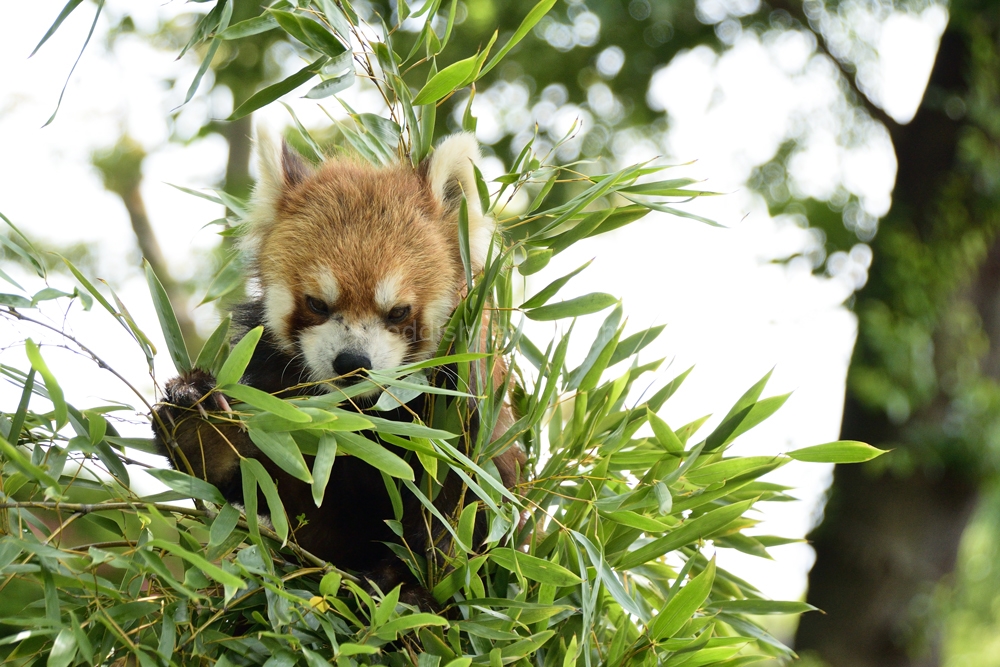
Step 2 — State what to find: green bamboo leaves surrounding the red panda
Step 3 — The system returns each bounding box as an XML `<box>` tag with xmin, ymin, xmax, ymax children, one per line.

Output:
<box><xmin>0</xmin><ymin>0</ymin><xmax>881</xmax><ymax>667</ymax></box>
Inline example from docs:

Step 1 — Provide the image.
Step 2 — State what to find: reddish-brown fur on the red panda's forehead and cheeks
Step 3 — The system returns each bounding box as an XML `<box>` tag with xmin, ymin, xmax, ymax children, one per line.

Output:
<box><xmin>257</xmin><ymin>158</ymin><xmax>462</xmax><ymax>366</ymax></box>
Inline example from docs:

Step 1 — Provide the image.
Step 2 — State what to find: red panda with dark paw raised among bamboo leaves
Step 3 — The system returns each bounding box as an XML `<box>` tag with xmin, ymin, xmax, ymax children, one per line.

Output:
<box><xmin>154</xmin><ymin>134</ymin><xmax>524</xmax><ymax>604</ymax></box>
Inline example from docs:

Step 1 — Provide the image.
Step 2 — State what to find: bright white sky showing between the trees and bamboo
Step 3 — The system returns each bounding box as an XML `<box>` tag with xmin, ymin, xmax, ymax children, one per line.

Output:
<box><xmin>0</xmin><ymin>0</ymin><xmax>946</xmax><ymax>612</ymax></box>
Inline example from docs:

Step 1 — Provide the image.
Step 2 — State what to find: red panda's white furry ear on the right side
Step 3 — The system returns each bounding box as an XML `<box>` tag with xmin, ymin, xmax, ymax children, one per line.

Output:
<box><xmin>418</xmin><ymin>132</ymin><xmax>496</xmax><ymax>273</ymax></box>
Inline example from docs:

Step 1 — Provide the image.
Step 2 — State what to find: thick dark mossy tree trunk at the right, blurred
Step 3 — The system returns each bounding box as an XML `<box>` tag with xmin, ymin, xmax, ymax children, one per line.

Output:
<box><xmin>795</xmin><ymin>15</ymin><xmax>1000</xmax><ymax>667</ymax></box>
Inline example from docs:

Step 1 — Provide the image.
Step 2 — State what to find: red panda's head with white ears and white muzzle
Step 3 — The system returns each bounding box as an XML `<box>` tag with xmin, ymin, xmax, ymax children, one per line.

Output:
<box><xmin>244</xmin><ymin>133</ymin><xmax>494</xmax><ymax>392</ymax></box>
